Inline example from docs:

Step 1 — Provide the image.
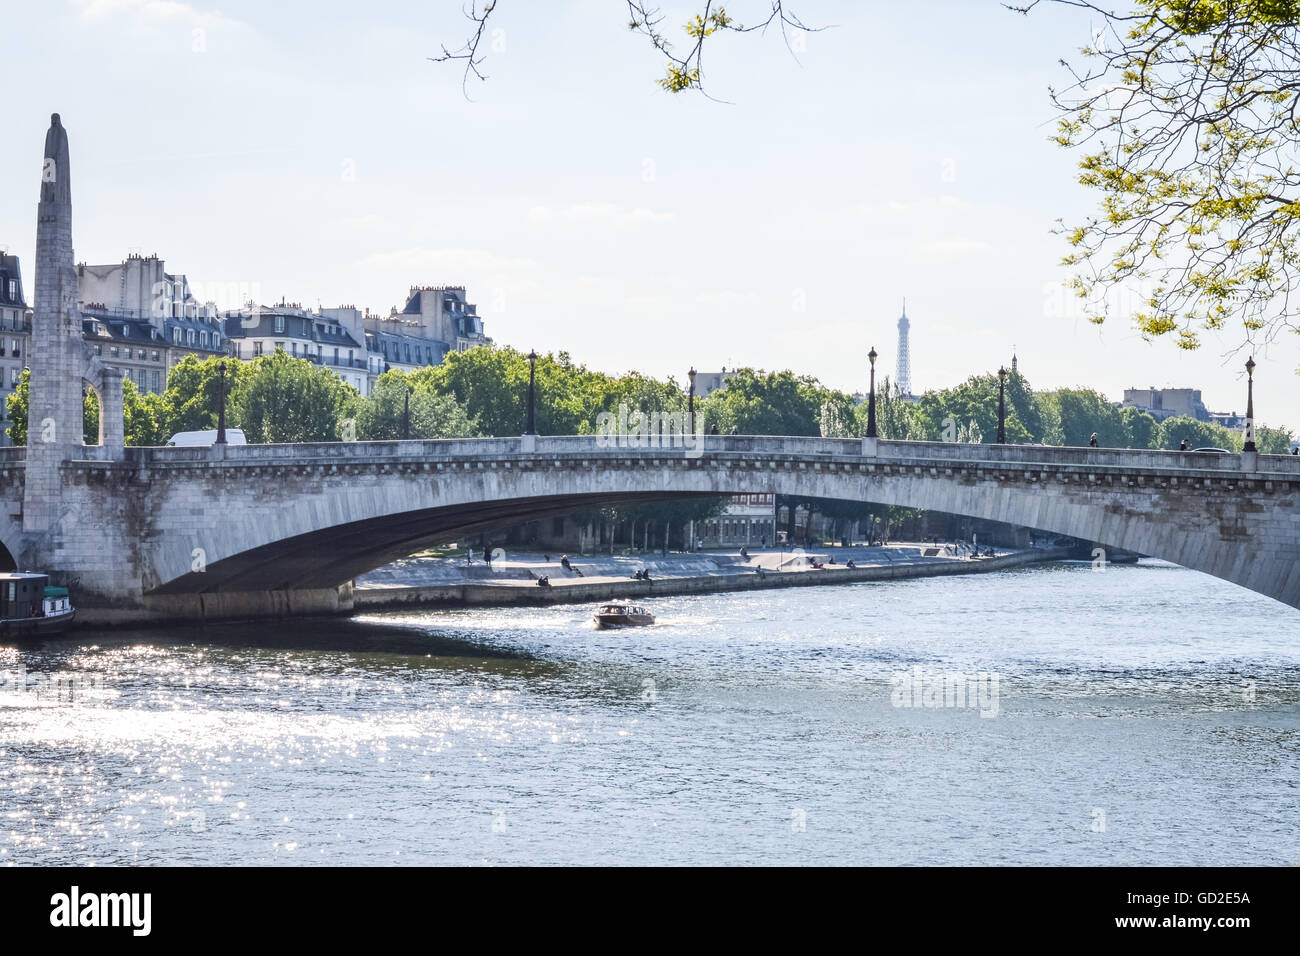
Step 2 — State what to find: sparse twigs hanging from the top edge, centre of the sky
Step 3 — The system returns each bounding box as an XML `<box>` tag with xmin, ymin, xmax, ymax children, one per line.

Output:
<box><xmin>429</xmin><ymin>0</ymin><xmax>822</xmax><ymax>99</ymax></box>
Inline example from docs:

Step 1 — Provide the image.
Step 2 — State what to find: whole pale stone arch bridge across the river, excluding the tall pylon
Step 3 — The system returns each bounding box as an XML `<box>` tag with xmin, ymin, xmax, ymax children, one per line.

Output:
<box><xmin>0</xmin><ymin>436</ymin><xmax>1300</xmax><ymax>623</ymax></box>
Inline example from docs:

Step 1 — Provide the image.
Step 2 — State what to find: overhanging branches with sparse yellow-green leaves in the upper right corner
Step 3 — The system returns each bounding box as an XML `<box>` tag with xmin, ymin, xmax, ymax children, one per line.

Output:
<box><xmin>1019</xmin><ymin>0</ymin><xmax>1300</xmax><ymax>349</ymax></box>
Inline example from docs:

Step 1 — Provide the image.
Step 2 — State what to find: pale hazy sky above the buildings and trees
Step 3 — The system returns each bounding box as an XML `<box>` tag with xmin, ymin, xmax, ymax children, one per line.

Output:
<box><xmin>0</xmin><ymin>0</ymin><xmax>1300</xmax><ymax>427</ymax></box>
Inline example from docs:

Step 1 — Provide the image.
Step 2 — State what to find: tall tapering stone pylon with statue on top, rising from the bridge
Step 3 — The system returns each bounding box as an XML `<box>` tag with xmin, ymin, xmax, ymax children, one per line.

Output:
<box><xmin>22</xmin><ymin>113</ymin><xmax>122</xmax><ymax>538</ymax></box>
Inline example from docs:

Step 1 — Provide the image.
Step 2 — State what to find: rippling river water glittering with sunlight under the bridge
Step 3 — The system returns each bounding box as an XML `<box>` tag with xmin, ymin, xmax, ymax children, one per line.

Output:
<box><xmin>0</xmin><ymin>561</ymin><xmax>1300</xmax><ymax>865</ymax></box>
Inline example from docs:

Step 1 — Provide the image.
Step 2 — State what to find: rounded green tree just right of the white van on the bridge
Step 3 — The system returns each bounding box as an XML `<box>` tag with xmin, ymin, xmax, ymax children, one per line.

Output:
<box><xmin>233</xmin><ymin>349</ymin><xmax>356</xmax><ymax>444</ymax></box>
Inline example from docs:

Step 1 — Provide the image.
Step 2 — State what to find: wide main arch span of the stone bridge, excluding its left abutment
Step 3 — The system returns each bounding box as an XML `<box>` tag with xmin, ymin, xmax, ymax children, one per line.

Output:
<box><xmin>129</xmin><ymin>437</ymin><xmax>1300</xmax><ymax>605</ymax></box>
